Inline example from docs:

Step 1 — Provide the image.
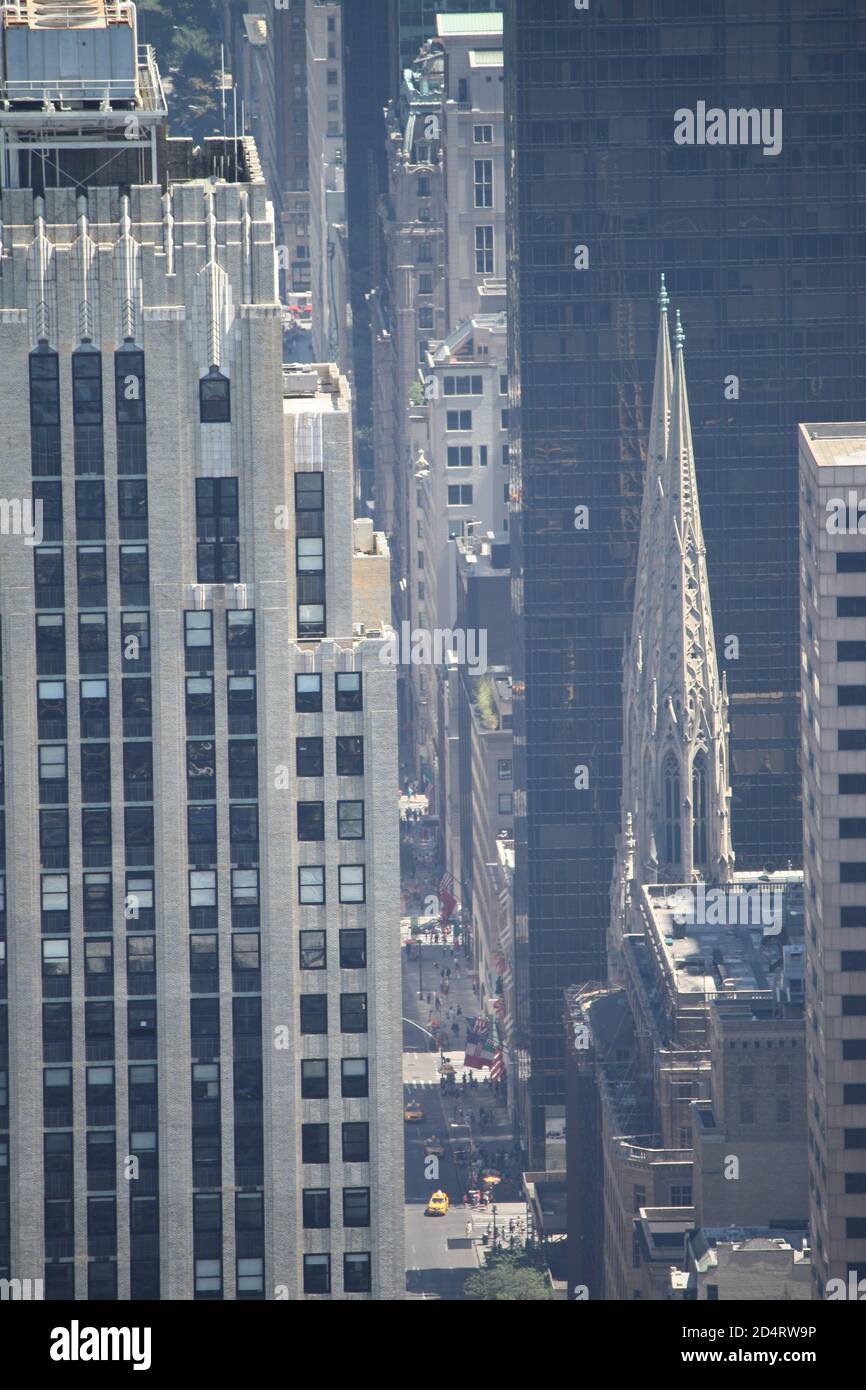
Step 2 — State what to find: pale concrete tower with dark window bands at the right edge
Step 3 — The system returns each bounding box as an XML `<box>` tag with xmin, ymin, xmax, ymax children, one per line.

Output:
<box><xmin>799</xmin><ymin>423</ymin><xmax>866</xmax><ymax>1298</ymax></box>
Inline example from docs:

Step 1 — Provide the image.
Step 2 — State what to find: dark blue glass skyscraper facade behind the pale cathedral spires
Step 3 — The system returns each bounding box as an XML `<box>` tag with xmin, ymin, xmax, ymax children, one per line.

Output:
<box><xmin>505</xmin><ymin>0</ymin><xmax>866</xmax><ymax>1161</ymax></box>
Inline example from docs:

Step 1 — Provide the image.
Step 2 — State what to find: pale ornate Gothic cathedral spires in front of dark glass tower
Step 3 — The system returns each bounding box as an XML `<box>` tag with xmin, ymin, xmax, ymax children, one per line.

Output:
<box><xmin>623</xmin><ymin>290</ymin><xmax>734</xmax><ymax>883</ymax></box>
